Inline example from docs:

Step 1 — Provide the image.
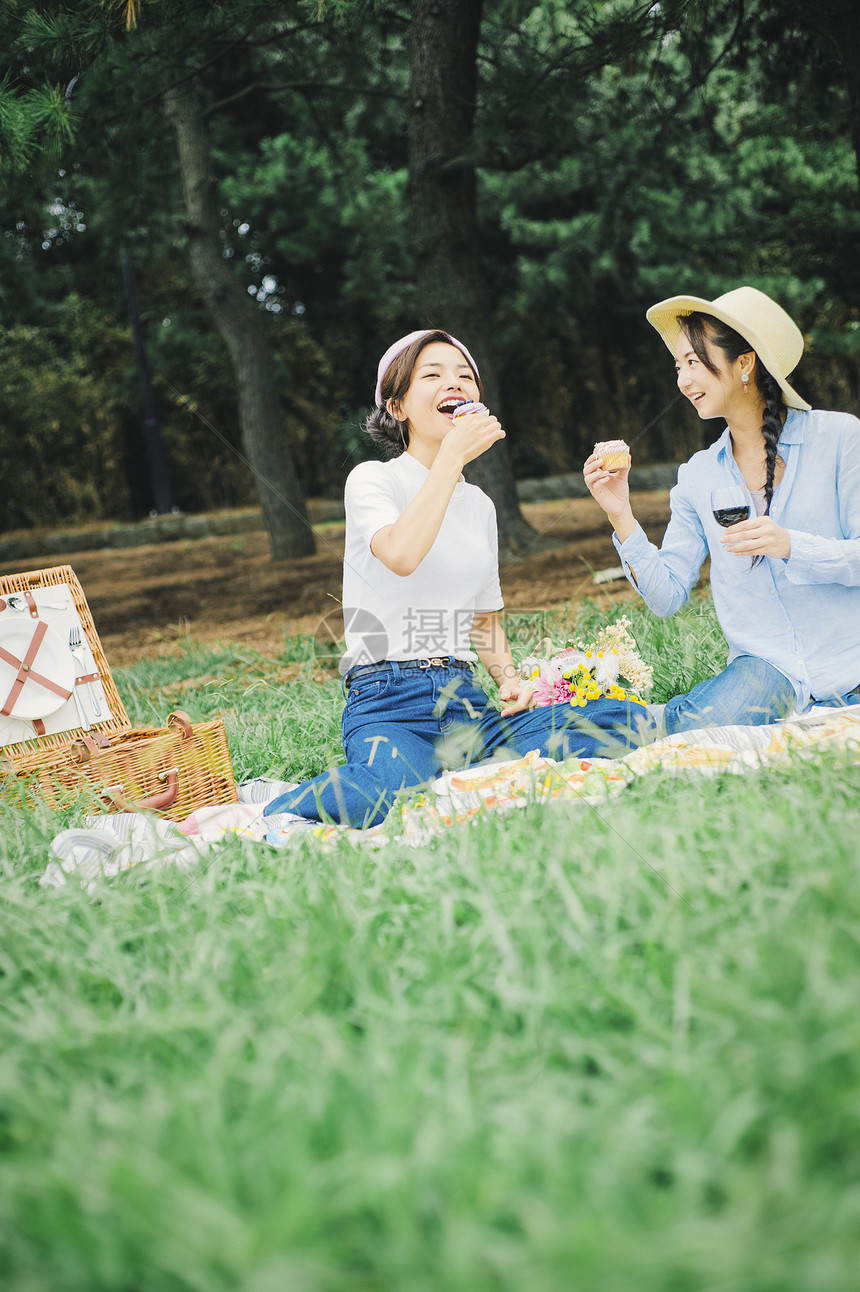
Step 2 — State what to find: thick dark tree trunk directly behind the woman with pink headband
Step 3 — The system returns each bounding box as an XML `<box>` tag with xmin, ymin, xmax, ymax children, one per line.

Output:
<box><xmin>408</xmin><ymin>0</ymin><xmax>536</xmax><ymax>553</ymax></box>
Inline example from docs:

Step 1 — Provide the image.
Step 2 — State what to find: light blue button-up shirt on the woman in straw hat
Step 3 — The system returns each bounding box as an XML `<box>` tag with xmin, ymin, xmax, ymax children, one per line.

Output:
<box><xmin>613</xmin><ymin>410</ymin><xmax>860</xmax><ymax>711</ymax></box>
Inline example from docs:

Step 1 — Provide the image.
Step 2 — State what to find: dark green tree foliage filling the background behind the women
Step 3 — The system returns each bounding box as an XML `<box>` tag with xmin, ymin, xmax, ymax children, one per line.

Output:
<box><xmin>0</xmin><ymin>0</ymin><xmax>860</xmax><ymax>523</ymax></box>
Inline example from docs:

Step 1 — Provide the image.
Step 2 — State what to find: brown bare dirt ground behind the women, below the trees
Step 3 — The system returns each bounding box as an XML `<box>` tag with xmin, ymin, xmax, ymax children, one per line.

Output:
<box><xmin>0</xmin><ymin>492</ymin><xmax>669</xmax><ymax>667</ymax></box>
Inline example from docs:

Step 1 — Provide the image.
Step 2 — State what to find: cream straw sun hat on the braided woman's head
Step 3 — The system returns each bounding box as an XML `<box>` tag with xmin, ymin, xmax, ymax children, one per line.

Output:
<box><xmin>646</xmin><ymin>287</ymin><xmax>810</xmax><ymax>411</ymax></box>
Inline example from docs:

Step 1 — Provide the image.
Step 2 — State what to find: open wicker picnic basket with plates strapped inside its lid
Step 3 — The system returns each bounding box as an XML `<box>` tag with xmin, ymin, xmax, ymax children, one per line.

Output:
<box><xmin>0</xmin><ymin>566</ymin><xmax>238</xmax><ymax>820</ymax></box>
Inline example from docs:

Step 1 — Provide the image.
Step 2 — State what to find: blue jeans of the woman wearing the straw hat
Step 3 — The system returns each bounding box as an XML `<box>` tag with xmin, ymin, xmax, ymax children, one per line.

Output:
<box><xmin>662</xmin><ymin>655</ymin><xmax>795</xmax><ymax>735</ymax></box>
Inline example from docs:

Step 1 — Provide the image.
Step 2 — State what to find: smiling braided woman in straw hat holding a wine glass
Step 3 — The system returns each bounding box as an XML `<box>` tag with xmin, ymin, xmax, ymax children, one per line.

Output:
<box><xmin>584</xmin><ymin>287</ymin><xmax>860</xmax><ymax>734</ymax></box>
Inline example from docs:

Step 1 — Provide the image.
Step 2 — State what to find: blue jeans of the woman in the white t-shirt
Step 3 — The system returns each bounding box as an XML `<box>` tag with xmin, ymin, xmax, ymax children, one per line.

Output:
<box><xmin>260</xmin><ymin>662</ymin><xmax>653</xmax><ymax>826</ymax></box>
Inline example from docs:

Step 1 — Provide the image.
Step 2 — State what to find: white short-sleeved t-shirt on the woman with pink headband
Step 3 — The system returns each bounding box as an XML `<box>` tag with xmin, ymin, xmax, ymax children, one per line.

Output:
<box><xmin>340</xmin><ymin>453</ymin><xmax>504</xmax><ymax>673</ymax></box>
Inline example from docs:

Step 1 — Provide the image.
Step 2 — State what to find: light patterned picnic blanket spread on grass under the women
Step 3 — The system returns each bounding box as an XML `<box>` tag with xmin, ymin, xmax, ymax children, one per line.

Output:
<box><xmin>40</xmin><ymin>705</ymin><xmax>860</xmax><ymax>886</ymax></box>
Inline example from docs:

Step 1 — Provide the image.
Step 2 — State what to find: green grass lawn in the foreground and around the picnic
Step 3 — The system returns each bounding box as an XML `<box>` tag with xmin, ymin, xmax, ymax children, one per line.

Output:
<box><xmin>0</xmin><ymin>603</ymin><xmax>860</xmax><ymax>1292</ymax></box>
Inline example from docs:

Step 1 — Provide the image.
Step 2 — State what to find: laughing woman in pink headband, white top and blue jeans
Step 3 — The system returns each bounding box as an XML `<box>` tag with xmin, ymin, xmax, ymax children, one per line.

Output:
<box><xmin>267</xmin><ymin>329</ymin><xmax>645</xmax><ymax>826</ymax></box>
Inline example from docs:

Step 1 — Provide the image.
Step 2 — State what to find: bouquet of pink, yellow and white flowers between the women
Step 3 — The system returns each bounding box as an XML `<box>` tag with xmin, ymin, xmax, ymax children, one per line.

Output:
<box><xmin>519</xmin><ymin>615</ymin><xmax>653</xmax><ymax>707</ymax></box>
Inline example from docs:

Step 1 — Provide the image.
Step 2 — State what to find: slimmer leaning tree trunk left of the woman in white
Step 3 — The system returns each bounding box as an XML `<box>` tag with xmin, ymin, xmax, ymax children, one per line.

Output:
<box><xmin>164</xmin><ymin>76</ymin><xmax>315</xmax><ymax>561</ymax></box>
